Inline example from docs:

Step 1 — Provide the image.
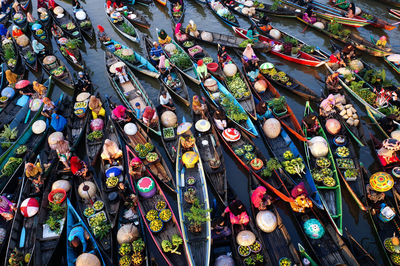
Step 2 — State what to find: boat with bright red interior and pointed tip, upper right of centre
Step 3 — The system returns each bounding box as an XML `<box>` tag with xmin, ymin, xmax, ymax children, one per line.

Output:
<box><xmin>232</xmin><ymin>27</ymin><xmax>325</xmax><ymax>67</ymax></box>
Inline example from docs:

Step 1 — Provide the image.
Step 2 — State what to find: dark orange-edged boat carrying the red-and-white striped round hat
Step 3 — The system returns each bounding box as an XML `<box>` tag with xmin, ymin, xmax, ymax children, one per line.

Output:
<box><xmin>208</xmin><ymin>105</ymin><xmax>292</xmax><ymax>202</ymax></box>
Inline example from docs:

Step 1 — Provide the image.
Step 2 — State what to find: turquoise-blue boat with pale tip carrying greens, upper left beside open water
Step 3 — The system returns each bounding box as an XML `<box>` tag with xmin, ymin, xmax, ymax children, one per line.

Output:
<box><xmin>102</xmin><ymin>36</ymin><xmax>160</xmax><ymax>78</ymax></box>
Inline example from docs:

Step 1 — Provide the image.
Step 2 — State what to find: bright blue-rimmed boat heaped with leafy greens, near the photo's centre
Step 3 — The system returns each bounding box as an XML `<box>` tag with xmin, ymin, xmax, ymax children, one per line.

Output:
<box><xmin>195</xmin><ymin>75</ymin><xmax>258</xmax><ymax>137</ymax></box>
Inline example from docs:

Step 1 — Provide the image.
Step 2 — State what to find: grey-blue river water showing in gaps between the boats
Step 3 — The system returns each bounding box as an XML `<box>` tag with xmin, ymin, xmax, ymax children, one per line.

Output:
<box><xmin>34</xmin><ymin>0</ymin><xmax>400</xmax><ymax>265</ymax></box>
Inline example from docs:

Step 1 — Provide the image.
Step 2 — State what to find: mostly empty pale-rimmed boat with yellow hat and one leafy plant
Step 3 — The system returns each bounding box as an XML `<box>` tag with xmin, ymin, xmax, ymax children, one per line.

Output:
<box><xmin>175</xmin><ymin>137</ymin><xmax>211</xmax><ymax>265</ymax></box>
